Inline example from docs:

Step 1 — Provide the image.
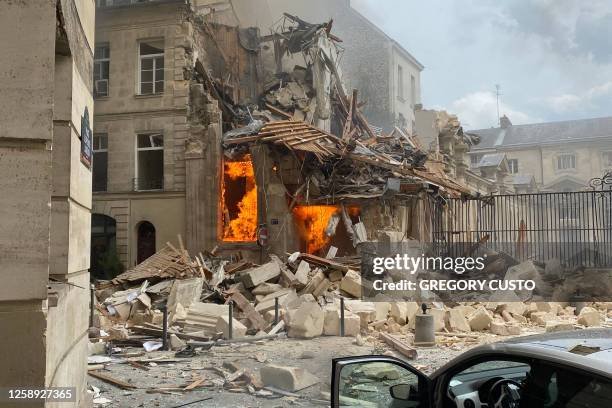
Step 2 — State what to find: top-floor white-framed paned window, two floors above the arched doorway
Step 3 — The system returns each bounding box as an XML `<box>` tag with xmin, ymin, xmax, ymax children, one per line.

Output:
<box><xmin>139</xmin><ymin>40</ymin><xmax>164</xmax><ymax>95</ymax></box>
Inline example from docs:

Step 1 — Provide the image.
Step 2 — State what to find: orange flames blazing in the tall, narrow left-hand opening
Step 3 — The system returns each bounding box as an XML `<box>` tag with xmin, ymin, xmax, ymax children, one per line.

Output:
<box><xmin>221</xmin><ymin>155</ymin><xmax>257</xmax><ymax>242</ymax></box>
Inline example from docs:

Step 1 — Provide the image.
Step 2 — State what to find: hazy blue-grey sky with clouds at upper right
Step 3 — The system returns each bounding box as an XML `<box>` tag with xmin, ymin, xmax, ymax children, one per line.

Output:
<box><xmin>351</xmin><ymin>0</ymin><xmax>612</xmax><ymax>129</ymax></box>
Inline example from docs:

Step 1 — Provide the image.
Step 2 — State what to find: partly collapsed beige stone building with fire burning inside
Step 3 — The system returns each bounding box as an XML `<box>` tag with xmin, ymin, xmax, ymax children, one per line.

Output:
<box><xmin>92</xmin><ymin>1</ymin><xmax>473</xmax><ymax>270</ymax></box>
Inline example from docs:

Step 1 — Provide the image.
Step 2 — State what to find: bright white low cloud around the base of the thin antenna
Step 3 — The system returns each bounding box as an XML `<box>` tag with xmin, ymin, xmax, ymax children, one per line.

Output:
<box><xmin>448</xmin><ymin>91</ymin><xmax>540</xmax><ymax>129</ymax></box>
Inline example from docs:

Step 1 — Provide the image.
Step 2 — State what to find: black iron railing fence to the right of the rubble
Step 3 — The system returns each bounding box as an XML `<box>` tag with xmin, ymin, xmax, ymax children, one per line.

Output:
<box><xmin>432</xmin><ymin>189</ymin><xmax>612</xmax><ymax>267</ymax></box>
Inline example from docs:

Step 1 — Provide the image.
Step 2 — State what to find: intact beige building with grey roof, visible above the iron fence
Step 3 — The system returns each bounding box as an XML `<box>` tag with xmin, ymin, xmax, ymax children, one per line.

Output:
<box><xmin>469</xmin><ymin>116</ymin><xmax>612</xmax><ymax>192</ymax></box>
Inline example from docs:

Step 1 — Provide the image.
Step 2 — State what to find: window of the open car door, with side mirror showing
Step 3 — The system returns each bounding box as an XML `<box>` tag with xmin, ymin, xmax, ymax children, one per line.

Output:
<box><xmin>339</xmin><ymin>362</ymin><xmax>424</xmax><ymax>408</ymax></box>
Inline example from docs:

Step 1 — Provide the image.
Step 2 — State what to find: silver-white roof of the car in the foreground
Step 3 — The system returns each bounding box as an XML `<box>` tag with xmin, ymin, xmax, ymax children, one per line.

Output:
<box><xmin>431</xmin><ymin>329</ymin><xmax>612</xmax><ymax>378</ymax></box>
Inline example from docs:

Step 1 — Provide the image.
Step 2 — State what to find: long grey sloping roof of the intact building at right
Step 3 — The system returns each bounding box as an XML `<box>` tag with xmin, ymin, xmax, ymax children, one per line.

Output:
<box><xmin>469</xmin><ymin>117</ymin><xmax>612</xmax><ymax>149</ymax></box>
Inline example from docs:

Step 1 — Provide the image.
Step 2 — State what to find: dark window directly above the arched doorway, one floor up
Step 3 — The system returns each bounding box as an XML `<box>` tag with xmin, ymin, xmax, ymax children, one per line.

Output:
<box><xmin>134</xmin><ymin>133</ymin><xmax>164</xmax><ymax>191</ymax></box>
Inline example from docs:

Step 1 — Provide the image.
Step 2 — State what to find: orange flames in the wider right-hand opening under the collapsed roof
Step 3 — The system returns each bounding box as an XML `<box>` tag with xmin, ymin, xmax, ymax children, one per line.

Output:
<box><xmin>293</xmin><ymin>205</ymin><xmax>340</xmax><ymax>254</ymax></box>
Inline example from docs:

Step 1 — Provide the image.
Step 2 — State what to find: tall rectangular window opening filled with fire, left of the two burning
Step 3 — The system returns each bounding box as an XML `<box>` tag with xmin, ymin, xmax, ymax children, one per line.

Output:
<box><xmin>221</xmin><ymin>154</ymin><xmax>257</xmax><ymax>242</ymax></box>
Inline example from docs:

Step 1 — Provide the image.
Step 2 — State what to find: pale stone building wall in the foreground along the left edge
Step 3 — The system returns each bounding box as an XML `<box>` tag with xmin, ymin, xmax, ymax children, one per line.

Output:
<box><xmin>0</xmin><ymin>0</ymin><xmax>95</xmax><ymax>407</ymax></box>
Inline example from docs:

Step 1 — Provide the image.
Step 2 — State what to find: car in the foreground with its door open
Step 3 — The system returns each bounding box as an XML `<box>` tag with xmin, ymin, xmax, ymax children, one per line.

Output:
<box><xmin>331</xmin><ymin>329</ymin><xmax>612</xmax><ymax>408</ymax></box>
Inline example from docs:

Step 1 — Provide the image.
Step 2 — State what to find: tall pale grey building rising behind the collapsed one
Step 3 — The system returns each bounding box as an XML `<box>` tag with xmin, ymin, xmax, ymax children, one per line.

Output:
<box><xmin>203</xmin><ymin>0</ymin><xmax>424</xmax><ymax>133</ymax></box>
